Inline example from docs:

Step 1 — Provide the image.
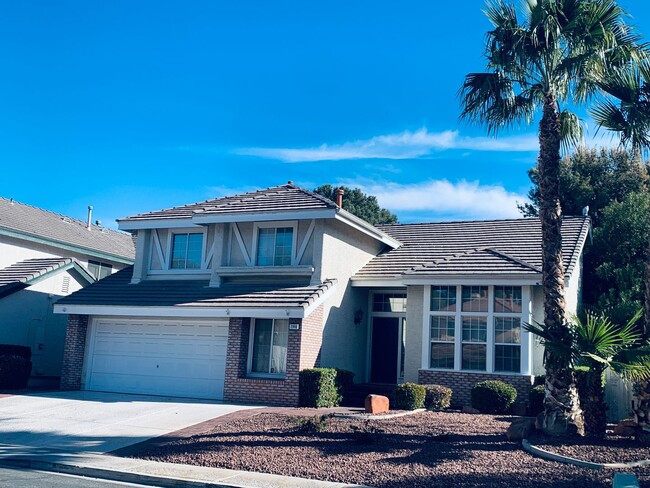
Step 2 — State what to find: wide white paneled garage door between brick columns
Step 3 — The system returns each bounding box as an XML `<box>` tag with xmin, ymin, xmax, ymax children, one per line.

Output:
<box><xmin>86</xmin><ymin>318</ymin><xmax>228</xmax><ymax>400</ymax></box>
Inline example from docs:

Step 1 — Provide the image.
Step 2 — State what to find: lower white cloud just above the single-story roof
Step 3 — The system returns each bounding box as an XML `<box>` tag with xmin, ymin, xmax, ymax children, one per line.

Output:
<box><xmin>347</xmin><ymin>180</ymin><xmax>528</xmax><ymax>221</ymax></box>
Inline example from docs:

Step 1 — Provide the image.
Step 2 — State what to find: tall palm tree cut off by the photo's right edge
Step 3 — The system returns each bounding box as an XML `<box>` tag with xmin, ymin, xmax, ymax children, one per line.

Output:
<box><xmin>591</xmin><ymin>60</ymin><xmax>650</xmax><ymax>438</ymax></box>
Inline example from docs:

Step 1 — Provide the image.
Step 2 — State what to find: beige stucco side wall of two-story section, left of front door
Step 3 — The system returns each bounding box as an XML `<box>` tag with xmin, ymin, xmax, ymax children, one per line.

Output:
<box><xmin>314</xmin><ymin>221</ymin><xmax>383</xmax><ymax>382</ymax></box>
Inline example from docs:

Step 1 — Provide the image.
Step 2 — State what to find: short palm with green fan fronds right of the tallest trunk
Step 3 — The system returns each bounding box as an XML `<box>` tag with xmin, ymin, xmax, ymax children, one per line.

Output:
<box><xmin>524</xmin><ymin>310</ymin><xmax>650</xmax><ymax>436</ymax></box>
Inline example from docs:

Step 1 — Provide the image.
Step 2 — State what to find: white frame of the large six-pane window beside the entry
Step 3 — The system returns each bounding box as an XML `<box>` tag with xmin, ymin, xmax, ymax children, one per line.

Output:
<box><xmin>421</xmin><ymin>282</ymin><xmax>532</xmax><ymax>376</ymax></box>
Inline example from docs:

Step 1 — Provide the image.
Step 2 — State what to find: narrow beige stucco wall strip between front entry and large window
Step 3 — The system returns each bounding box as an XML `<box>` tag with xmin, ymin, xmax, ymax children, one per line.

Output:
<box><xmin>404</xmin><ymin>286</ymin><xmax>425</xmax><ymax>383</ymax></box>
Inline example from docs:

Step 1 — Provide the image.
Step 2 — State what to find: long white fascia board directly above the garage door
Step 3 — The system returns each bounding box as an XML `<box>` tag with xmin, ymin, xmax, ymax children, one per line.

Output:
<box><xmin>54</xmin><ymin>303</ymin><xmax>307</xmax><ymax>319</ymax></box>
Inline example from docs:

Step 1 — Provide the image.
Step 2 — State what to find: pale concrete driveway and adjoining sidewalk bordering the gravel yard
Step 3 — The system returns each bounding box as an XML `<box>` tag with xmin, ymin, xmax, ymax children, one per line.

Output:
<box><xmin>0</xmin><ymin>391</ymin><xmax>368</xmax><ymax>488</ymax></box>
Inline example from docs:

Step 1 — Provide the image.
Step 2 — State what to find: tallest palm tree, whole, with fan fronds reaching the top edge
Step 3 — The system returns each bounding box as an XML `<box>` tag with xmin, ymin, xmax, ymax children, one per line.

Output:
<box><xmin>459</xmin><ymin>0</ymin><xmax>639</xmax><ymax>433</ymax></box>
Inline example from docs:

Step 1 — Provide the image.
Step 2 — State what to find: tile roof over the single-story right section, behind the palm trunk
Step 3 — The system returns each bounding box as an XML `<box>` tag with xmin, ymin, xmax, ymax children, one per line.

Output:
<box><xmin>355</xmin><ymin>217</ymin><xmax>589</xmax><ymax>278</ymax></box>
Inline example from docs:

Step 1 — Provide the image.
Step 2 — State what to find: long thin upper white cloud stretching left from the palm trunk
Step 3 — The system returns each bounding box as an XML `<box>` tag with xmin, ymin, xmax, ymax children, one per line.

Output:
<box><xmin>234</xmin><ymin>128</ymin><xmax>539</xmax><ymax>163</ymax></box>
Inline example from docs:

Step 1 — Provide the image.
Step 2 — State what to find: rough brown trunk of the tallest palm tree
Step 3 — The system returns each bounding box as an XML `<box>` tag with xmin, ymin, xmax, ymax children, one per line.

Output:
<box><xmin>537</xmin><ymin>93</ymin><xmax>584</xmax><ymax>435</ymax></box>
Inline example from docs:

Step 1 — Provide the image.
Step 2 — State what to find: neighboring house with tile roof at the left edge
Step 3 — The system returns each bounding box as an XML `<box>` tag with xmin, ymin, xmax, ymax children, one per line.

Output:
<box><xmin>0</xmin><ymin>198</ymin><xmax>135</xmax><ymax>383</ymax></box>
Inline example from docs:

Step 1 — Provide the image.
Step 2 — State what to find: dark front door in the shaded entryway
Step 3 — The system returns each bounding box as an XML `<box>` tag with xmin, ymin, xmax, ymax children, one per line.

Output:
<box><xmin>370</xmin><ymin>317</ymin><xmax>400</xmax><ymax>384</ymax></box>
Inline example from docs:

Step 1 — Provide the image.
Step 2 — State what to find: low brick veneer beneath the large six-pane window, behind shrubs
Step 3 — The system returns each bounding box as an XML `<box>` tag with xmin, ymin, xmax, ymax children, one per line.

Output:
<box><xmin>418</xmin><ymin>369</ymin><xmax>534</xmax><ymax>407</ymax></box>
